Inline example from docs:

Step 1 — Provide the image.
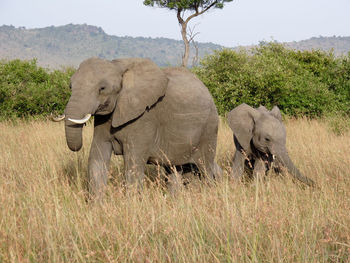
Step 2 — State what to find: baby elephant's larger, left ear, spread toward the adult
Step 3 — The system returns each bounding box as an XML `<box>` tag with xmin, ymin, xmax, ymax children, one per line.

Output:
<box><xmin>227</xmin><ymin>103</ymin><xmax>262</xmax><ymax>149</ymax></box>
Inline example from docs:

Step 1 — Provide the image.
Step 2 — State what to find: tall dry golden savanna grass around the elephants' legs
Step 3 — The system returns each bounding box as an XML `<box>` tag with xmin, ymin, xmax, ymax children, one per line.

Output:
<box><xmin>0</xmin><ymin>119</ymin><xmax>350</xmax><ymax>262</ymax></box>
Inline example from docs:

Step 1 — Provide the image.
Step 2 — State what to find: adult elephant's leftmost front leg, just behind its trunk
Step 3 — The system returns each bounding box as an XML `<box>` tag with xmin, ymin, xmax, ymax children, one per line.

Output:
<box><xmin>88</xmin><ymin>139</ymin><xmax>112</xmax><ymax>199</ymax></box>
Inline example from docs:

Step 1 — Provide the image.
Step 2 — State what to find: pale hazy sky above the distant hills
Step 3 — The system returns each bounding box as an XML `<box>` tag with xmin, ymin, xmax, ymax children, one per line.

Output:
<box><xmin>0</xmin><ymin>0</ymin><xmax>350</xmax><ymax>47</ymax></box>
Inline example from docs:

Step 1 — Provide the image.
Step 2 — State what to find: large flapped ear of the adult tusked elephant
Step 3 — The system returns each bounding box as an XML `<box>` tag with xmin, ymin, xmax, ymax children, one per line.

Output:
<box><xmin>112</xmin><ymin>59</ymin><xmax>168</xmax><ymax>127</ymax></box>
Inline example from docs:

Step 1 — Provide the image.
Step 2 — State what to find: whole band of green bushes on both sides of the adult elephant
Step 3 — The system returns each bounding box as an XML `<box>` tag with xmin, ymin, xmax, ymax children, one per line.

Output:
<box><xmin>0</xmin><ymin>43</ymin><xmax>350</xmax><ymax>120</ymax></box>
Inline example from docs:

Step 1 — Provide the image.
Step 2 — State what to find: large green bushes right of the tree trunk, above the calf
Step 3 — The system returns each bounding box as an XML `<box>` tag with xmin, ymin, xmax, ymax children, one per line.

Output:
<box><xmin>194</xmin><ymin>43</ymin><xmax>350</xmax><ymax>117</ymax></box>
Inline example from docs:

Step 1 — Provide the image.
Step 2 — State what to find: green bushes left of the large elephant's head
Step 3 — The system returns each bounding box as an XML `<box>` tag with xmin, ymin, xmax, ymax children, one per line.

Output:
<box><xmin>0</xmin><ymin>60</ymin><xmax>74</xmax><ymax>119</ymax></box>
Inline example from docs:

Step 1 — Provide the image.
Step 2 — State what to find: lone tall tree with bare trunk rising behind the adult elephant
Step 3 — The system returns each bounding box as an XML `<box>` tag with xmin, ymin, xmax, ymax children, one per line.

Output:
<box><xmin>143</xmin><ymin>0</ymin><xmax>233</xmax><ymax>67</ymax></box>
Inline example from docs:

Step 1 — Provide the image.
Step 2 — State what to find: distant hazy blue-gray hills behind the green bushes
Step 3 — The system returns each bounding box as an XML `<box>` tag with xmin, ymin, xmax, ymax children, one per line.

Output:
<box><xmin>0</xmin><ymin>24</ymin><xmax>350</xmax><ymax>68</ymax></box>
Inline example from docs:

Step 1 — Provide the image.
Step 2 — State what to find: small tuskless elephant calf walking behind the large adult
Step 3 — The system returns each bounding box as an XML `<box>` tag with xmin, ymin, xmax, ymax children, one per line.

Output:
<box><xmin>227</xmin><ymin>103</ymin><xmax>315</xmax><ymax>186</ymax></box>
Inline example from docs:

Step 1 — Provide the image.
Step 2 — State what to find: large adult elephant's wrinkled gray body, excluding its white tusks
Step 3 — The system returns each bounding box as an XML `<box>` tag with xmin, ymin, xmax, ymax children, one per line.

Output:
<box><xmin>65</xmin><ymin>58</ymin><xmax>220</xmax><ymax>196</ymax></box>
